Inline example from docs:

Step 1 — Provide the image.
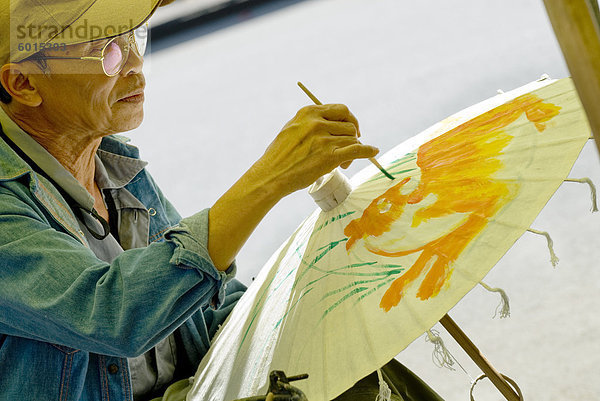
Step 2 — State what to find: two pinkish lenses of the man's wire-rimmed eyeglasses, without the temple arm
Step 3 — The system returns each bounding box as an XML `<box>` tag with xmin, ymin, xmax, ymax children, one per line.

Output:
<box><xmin>102</xmin><ymin>25</ymin><xmax>148</xmax><ymax>76</ymax></box>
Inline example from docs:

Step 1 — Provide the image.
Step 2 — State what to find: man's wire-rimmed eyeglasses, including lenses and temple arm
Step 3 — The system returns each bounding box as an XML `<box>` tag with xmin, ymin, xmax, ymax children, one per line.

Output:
<box><xmin>29</xmin><ymin>23</ymin><xmax>148</xmax><ymax>77</ymax></box>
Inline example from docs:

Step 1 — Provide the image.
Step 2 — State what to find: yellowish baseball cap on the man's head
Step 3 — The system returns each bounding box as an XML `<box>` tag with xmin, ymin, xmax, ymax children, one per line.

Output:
<box><xmin>0</xmin><ymin>0</ymin><xmax>160</xmax><ymax>65</ymax></box>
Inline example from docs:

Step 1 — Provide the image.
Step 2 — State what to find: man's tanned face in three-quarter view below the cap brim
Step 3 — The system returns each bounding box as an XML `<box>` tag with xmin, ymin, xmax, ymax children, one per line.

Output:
<box><xmin>27</xmin><ymin>36</ymin><xmax>145</xmax><ymax>137</ymax></box>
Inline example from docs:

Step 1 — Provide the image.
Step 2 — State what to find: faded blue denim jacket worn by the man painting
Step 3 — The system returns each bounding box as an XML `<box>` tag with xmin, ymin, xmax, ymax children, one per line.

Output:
<box><xmin>0</xmin><ymin>130</ymin><xmax>244</xmax><ymax>401</ymax></box>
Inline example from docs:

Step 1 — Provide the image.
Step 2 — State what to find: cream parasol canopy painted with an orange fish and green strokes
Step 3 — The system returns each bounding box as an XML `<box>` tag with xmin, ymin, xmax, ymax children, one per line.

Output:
<box><xmin>188</xmin><ymin>79</ymin><xmax>590</xmax><ymax>401</ymax></box>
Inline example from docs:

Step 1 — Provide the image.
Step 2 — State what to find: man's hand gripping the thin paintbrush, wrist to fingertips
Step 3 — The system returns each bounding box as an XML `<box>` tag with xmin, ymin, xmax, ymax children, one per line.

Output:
<box><xmin>252</xmin><ymin>104</ymin><xmax>379</xmax><ymax>197</ymax></box>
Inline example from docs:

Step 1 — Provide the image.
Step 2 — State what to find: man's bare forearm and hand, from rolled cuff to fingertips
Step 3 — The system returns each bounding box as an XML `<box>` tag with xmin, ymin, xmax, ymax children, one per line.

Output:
<box><xmin>208</xmin><ymin>104</ymin><xmax>379</xmax><ymax>270</ymax></box>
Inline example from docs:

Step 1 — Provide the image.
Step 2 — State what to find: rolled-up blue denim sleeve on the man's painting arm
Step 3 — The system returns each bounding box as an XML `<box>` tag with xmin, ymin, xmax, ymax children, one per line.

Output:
<box><xmin>0</xmin><ymin>182</ymin><xmax>235</xmax><ymax>357</ymax></box>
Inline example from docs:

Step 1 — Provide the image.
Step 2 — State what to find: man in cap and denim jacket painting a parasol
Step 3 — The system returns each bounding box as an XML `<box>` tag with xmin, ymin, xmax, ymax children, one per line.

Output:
<box><xmin>0</xmin><ymin>0</ymin><xmax>440</xmax><ymax>401</ymax></box>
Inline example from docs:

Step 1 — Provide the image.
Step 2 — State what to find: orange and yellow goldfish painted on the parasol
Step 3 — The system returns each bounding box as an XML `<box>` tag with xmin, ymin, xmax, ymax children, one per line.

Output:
<box><xmin>344</xmin><ymin>94</ymin><xmax>560</xmax><ymax>311</ymax></box>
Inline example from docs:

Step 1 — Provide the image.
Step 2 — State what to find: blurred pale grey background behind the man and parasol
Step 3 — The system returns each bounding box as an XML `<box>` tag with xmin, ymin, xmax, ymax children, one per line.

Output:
<box><xmin>128</xmin><ymin>0</ymin><xmax>600</xmax><ymax>401</ymax></box>
